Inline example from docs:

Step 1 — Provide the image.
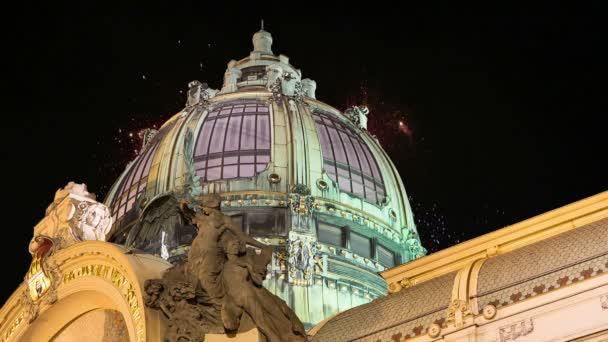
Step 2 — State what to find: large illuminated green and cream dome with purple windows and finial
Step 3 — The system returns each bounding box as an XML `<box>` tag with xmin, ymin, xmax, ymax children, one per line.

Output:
<box><xmin>105</xmin><ymin>29</ymin><xmax>426</xmax><ymax>326</ymax></box>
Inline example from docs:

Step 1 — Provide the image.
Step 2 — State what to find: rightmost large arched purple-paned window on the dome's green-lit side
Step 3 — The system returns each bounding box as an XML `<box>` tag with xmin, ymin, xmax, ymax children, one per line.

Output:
<box><xmin>312</xmin><ymin>112</ymin><xmax>386</xmax><ymax>203</ymax></box>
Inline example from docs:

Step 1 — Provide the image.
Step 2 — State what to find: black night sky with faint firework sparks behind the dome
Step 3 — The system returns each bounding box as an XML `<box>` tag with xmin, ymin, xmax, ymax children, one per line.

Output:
<box><xmin>0</xmin><ymin>1</ymin><xmax>608</xmax><ymax>302</ymax></box>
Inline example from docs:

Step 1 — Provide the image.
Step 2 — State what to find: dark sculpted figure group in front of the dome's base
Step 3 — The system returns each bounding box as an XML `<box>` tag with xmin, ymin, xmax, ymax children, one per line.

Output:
<box><xmin>144</xmin><ymin>195</ymin><xmax>306</xmax><ymax>342</ymax></box>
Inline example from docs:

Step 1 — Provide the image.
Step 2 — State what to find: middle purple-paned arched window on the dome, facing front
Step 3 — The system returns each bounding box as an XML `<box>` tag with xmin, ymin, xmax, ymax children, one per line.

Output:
<box><xmin>194</xmin><ymin>100</ymin><xmax>270</xmax><ymax>181</ymax></box>
